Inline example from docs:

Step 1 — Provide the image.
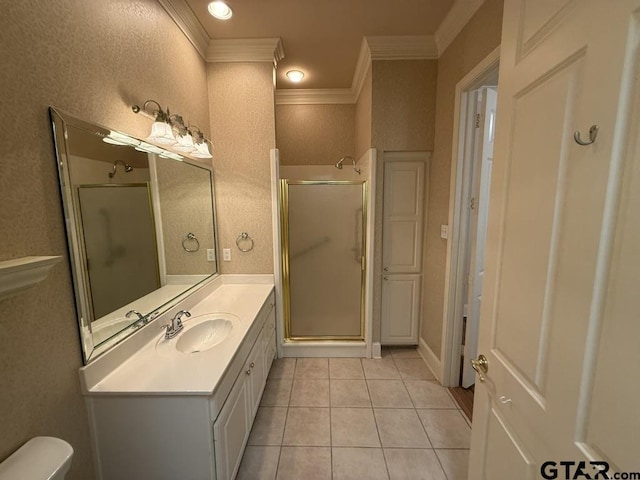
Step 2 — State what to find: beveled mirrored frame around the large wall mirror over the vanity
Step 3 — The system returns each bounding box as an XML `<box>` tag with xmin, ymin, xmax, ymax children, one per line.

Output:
<box><xmin>49</xmin><ymin>106</ymin><xmax>220</xmax><ymax>365</ymax></box>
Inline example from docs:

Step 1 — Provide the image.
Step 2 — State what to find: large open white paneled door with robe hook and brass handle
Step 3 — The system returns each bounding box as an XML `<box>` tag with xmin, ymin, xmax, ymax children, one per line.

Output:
<box><xmin>469</xmin><ymin>0</ymin><xmax>640</xmax><ymax>480</ymax></box>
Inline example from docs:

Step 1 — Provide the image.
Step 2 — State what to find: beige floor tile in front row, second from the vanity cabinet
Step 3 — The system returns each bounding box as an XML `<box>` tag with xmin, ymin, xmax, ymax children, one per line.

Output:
<box><xmin>277</xmin><ymin>447</ymin><xmax>331</xmax><ymax>480</ymax></box>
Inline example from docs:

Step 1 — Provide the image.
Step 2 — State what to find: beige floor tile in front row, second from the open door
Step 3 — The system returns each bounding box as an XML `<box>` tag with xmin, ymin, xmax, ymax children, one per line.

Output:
<box><xmin>384</xmin><ymin>448</ymin><xmax>448</xmax><ymax>480</ymax></box>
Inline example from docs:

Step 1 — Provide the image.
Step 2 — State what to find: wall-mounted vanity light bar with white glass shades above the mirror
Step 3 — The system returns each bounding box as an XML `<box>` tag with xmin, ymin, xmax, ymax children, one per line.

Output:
<box><xmin>131</xmin><ymin>100</ymin><xmax>212</xmax><ymax>160</ymax></box>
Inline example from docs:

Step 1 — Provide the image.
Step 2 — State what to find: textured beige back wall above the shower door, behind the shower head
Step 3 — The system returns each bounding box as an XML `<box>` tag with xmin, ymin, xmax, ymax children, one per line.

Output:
<box><xmin>276</xmin><ymin>105</ymin><xmax>356</xmax><ymax>165</ymax></box>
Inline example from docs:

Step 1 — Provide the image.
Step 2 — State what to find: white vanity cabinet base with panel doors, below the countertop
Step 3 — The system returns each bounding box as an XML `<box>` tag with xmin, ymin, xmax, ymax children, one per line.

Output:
<box><xmin>86</xmin><ymin>290</ymin><xmax>276</xmax><ymax>480</ymax></box>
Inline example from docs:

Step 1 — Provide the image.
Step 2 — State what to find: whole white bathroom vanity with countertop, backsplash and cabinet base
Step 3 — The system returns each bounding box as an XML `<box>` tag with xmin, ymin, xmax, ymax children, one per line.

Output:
<box><xmin>81</xmin><ymin>275</ymin><xmax>276</xmax><ymax>480</ymax></box>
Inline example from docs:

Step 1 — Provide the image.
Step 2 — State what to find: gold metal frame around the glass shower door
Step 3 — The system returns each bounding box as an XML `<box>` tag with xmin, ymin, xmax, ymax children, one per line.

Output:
<box><xmin>280</xmin><ymin>178</ymin><xmax>367</xmax><ymax>343</ymax></box>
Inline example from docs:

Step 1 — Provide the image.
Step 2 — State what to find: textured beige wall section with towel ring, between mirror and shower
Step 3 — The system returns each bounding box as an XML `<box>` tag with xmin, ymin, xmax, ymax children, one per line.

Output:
<box><xmin>208</xmin><ymin>63</ymin><xmax>276</xmax><ymax>273</ymax></box>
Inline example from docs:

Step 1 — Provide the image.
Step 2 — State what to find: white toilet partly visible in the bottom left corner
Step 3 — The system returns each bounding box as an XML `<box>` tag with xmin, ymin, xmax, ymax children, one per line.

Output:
<box><xmin>0</xmin><ymin>437</ymin><xmax>73</xmax><ymax>480</ymax></box>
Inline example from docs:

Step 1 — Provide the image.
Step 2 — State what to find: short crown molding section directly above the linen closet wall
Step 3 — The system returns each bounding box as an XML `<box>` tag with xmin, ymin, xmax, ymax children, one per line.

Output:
<box><xmin>365</xmin><ymin>35</ymin><xmax>438</xmax><ymax>60</ymax></box>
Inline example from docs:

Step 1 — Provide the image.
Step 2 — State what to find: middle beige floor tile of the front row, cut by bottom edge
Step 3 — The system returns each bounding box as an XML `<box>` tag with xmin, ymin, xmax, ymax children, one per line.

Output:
<box><xmin>332</xmin><ymin>448</ymin><xmax>389</xmax><ymax>480</ymax></box>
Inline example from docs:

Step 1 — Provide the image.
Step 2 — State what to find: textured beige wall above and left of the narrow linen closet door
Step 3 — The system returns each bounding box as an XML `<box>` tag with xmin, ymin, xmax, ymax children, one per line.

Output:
<box><xmin>371</xmin><ymin>60</ymin><xmax>438</xmax><ymax>342</ymax></box>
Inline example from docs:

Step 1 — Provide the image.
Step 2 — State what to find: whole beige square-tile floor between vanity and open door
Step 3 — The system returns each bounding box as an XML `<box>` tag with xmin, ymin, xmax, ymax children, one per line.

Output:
<box><xmin>237</xmin><ymin>348</ymin><xmax>471</xmax><ymax>480</ymax></box>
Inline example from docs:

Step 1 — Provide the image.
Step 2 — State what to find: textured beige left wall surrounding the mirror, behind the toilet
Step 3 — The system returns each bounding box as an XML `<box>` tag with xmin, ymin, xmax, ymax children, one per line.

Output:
<box><xmin>0</xmin><ymin>0</ymin><xmax>209</xmax><ymax>480</ymax></box>
